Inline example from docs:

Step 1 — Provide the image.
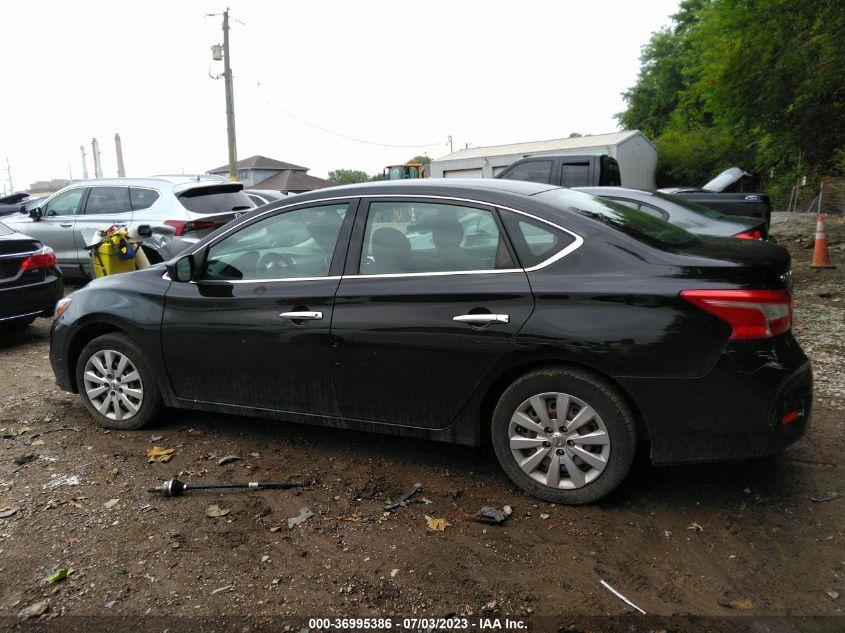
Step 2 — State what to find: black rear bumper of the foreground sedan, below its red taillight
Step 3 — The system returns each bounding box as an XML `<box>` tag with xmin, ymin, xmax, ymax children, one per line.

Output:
<box><xmin>619</xmin><ymin>333</ymin><xmax>813</xmax><ymax>464</ymax></box>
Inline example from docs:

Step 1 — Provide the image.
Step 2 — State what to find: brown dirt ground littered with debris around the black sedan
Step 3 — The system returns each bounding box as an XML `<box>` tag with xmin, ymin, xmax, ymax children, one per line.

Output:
<box><xmin>0</xmin><ymin>216</ymin><xmax>845</xmax><ymax>631</ymax></box>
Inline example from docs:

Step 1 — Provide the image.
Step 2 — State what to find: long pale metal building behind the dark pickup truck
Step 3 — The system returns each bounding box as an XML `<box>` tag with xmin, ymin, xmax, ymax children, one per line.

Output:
<box><xmin>431</xmin><ymin>130</ymin><xmax>657</xmax><ymax>191</ymax></box>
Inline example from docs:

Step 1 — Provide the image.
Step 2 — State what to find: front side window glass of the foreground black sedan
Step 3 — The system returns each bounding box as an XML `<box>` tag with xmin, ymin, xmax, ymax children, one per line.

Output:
<box><xmin>203</xmin><ymin>204</ymin><xmax>349</xmax><ymax>281</ymax></box>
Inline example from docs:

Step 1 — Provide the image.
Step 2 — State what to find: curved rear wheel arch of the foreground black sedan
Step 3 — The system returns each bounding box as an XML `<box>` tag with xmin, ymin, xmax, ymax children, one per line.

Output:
<box><xmin>478</xmin><ymin>359</ymin><xmax>649</xmax><ymax>446</ymax></box>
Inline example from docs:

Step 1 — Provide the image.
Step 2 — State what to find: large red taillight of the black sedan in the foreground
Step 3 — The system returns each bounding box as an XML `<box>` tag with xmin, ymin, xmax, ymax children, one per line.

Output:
<box><xmin>681</xmin><ymin>290</ymin><xmax>792</xmax><ymax>339</ymax></box>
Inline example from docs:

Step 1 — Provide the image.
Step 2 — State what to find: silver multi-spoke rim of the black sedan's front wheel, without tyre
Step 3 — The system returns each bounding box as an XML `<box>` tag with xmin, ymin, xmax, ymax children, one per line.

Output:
<box><xmin>83</xmin><ymin>349</ymin><xmax>144</xmax><ymax>421</ymax></box>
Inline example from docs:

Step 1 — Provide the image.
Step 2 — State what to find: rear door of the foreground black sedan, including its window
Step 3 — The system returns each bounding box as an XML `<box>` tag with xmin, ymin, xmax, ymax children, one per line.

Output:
<box><xmin>332</xmin><ymin>197</ymin><xmax>533</xmax><ymax>428</ymax></box>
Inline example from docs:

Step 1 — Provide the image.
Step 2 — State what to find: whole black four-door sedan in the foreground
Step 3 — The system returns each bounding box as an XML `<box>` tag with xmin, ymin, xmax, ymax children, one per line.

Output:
<box><xmin>50</xmin><ymin>179</ymin><xmax>812</xmax><ymax>503</ymax></box>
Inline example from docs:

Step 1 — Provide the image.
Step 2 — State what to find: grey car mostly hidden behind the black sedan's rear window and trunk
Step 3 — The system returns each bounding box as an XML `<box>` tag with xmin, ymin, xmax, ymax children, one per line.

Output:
<box><xmin>576</xmin><ymin>187</ymin><xmax>768</xmax><ymax>240</ymax></box>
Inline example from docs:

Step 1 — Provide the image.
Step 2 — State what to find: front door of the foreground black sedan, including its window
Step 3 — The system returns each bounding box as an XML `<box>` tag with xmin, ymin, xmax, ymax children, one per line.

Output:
<box><xmin>162</xmin><ymin>202</ymin><xmax>354</xmax><ymax>415</ymax></box>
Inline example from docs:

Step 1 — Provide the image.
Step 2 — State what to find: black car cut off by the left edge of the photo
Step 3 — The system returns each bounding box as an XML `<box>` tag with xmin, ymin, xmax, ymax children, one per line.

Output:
<box><xmin>0</xmin><ymin>223</ymin><xmax>62</xmax><ymax>327</ymax></box>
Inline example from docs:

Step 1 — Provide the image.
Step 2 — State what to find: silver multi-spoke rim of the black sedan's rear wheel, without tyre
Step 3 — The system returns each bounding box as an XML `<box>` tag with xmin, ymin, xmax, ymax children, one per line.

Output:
<box><xmin>508</xmin><ymin>392</ymin><xmax>610</xmax><ymax>490</ymax></box>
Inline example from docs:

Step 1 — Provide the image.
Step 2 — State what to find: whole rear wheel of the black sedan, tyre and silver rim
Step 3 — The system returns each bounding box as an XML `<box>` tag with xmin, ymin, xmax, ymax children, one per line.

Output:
<box><xmin>492</xmin><ymin>369</ymin><xmax>637</xmax><ymax>504</ymax></box>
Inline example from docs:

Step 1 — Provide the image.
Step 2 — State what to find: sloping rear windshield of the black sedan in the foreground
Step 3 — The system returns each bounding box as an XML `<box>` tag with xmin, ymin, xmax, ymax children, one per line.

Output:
<box><xmin>537</xmin><ymin>189</ymin><xmax>698</xmax><ymax>246</ymax></box>
